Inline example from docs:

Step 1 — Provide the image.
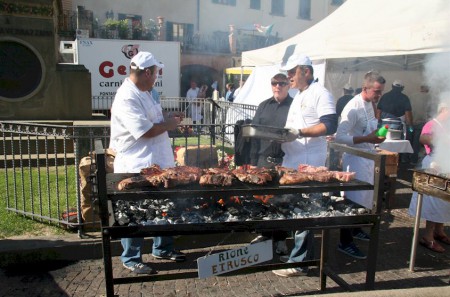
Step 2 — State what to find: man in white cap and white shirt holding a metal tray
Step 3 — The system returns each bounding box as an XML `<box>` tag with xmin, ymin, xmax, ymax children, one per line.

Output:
<box><xmin>273</xmin><ymin>54</ymin><xmax>338</xmax><ymax>277</ymax></box>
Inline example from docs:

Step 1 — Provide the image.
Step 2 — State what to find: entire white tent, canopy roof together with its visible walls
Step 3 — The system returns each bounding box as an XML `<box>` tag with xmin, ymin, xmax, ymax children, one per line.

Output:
<box><xmin>237</xmin><ymin>0</ymin><xmax>450</xmax><ymax>121</ymax></box>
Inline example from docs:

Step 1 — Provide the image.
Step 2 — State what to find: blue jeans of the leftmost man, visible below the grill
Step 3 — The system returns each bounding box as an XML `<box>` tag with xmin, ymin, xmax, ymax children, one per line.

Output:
<box><xmin>120</xmin><ymin>236</ymin><xmax>173</xmax><ymax>266</ymax></box>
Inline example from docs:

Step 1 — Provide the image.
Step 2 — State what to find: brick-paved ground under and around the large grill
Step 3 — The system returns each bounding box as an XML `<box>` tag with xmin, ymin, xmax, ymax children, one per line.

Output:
<box><xmin>0</xmin><ymin>163</ymin><xmax>450</xmax><ymax>297</ymax></box>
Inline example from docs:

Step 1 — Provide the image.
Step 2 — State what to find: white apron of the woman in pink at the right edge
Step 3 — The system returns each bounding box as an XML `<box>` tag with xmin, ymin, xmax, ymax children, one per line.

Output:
<box><xmin>408</xmin><ymin>155</ymin><xmax>450</xmax><ymax>223</ymax></box>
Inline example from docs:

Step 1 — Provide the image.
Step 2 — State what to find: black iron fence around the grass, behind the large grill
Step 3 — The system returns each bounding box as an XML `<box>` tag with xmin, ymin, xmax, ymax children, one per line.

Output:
<box><xmin>0</xmin><ymin>102</ymin><xmax>256</xmax><ymax>236</ymax></box>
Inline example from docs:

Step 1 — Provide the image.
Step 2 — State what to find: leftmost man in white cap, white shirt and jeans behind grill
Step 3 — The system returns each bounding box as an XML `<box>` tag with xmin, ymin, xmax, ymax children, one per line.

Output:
<box><xmin>110</xmin><ymin>52</ymin><xmax>186</xmax><ymax>274</ymax></box>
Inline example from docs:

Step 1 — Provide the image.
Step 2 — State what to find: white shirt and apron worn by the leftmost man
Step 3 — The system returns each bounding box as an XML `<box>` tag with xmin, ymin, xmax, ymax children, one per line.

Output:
<box><xmin>110</xmin><ymin>78</ymin><xmax>175</xmax><ymax>173</ymax></box>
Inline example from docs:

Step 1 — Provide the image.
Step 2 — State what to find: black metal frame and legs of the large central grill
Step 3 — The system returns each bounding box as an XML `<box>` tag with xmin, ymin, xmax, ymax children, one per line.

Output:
<box><xmin>95</xmin><ymin>141</ymin><xmax>385</xmax><ymax>296</ymax></box>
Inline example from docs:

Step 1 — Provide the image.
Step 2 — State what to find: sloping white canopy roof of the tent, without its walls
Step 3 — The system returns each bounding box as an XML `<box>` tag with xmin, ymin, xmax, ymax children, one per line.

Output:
<box><xmin>241</xmin><ymin>0</ymin><xmax>450</xmax><ymax>66</ymax></box>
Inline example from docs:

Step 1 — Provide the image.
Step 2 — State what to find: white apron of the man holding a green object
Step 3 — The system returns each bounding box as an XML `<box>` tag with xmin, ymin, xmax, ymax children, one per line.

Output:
<box><xmin>342</xmin><ymin>119</ymin><xmax>378</xmax><ymax>209</ymax></box>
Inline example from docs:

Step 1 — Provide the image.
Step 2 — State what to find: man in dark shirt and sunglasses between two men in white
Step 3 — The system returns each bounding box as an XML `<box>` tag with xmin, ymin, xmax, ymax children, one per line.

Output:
<box><xmin>250</xmin><ymin>73</ymin><xmax>293</xmax><ymax>168</ymax></box>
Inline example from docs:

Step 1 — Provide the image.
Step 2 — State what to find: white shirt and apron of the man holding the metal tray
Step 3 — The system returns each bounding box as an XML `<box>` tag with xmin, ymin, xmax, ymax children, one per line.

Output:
<box><xmin>281</xmin><ymin>82</ymin><xmax>336</xmax><ymax>169</ymax></box>
